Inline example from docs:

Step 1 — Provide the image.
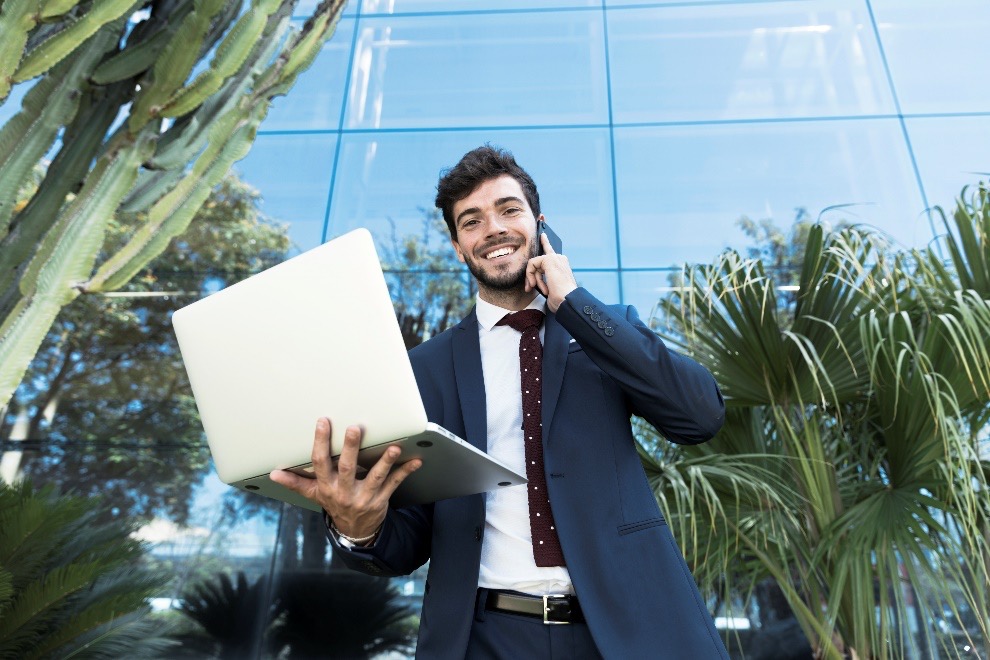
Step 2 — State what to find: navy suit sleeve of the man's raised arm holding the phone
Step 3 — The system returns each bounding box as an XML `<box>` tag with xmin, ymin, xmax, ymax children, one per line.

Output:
<box><xmin>556</xmin><ymin>287</ymin><xmax>725</xmax><ymax>444</ymax></box>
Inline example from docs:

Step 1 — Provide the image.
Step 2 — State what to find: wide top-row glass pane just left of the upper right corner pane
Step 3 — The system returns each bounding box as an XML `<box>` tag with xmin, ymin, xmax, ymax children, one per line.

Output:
<box><xmin>608</xmin><ymin>0</ymin><xmax>894</xmax><ymax>123</ymax></box>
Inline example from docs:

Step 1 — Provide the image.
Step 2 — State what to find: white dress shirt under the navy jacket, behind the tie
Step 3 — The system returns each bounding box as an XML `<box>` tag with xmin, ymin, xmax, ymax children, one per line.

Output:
<box><xmin>477</xmin><ymin>295</ymin><xmax>574</xmax><ymax>595</ymax></box>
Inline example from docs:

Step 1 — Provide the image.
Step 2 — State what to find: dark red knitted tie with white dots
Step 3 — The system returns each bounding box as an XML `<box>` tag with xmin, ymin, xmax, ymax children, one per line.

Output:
<box><xmin>497</xmin><ymin>309</ymin><xmax>564</xmax><ymax>566</ymax></box>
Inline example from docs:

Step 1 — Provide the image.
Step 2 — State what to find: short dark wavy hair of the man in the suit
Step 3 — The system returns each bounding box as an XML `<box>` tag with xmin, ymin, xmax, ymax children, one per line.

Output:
<box><xmin>436</xmin><ymin>144</ymin><xmax>540</xmax><ymax>240</ymax></box>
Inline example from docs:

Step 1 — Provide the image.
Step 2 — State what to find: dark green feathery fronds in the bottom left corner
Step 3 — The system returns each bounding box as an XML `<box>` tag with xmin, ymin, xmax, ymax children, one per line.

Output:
<box><xmin>0</xmin><ymin>483</ymin><xmax>170</xmax><ymax>660</ymax></box>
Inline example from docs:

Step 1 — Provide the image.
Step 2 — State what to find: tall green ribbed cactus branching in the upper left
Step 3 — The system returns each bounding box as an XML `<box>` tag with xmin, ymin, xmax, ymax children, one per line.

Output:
<box><xmin>0</xmin><ymin>0</ymin><xmax>352</xmax><ymax>407</ymax></box>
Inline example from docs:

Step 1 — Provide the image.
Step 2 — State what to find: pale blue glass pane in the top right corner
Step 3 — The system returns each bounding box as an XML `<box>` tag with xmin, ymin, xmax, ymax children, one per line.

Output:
<box><xmin>872</xmin><ymin>0</ymin><xmax>990</xmax><ymax>113</ymax></box>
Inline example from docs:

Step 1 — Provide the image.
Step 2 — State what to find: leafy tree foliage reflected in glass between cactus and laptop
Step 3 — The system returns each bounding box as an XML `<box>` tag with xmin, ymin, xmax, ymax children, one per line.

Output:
<box><xmin>2</xmin><ymin>177</ymin><xmax>289</xmax><ymax>523</ymax></box>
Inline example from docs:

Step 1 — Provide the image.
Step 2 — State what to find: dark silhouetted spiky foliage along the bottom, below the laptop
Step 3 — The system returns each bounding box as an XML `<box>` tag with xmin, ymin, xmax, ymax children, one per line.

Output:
<box><xmin>179</xmin><ymin>571</ymin><xmax>415</xmax><ymax>658</ymax></box>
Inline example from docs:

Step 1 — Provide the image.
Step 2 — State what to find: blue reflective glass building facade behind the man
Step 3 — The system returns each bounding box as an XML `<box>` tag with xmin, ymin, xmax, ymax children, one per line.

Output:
<box><xmin>0</xmin><ymin>0</ymin><xmax>990</xmax><ymax>656</ymax></box>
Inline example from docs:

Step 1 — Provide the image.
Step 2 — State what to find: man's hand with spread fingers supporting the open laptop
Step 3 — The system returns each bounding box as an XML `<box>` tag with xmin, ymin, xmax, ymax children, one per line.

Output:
<box><xmin>269</xmin><ymin>417</ymin><xmax>423</xmax><ymax>538</ymax></box>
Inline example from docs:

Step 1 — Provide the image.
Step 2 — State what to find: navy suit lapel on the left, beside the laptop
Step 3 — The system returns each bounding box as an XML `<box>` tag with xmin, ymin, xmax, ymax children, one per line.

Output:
<box><xmin>453</xmin><ymin>309</ymin><xmax>488</xmax><ymax>452</ymax></box>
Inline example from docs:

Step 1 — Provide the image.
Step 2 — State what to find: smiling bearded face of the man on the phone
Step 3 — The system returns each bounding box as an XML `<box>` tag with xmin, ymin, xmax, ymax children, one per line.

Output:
<box><xmin>451</xmin><ymin>175</ymin><xmax>542</xmax><ymax>291</ymax></box>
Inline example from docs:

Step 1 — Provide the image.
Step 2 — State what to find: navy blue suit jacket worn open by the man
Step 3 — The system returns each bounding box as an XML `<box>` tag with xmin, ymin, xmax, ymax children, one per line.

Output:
<box><xmin>337</xmin><ymin>288</ymin><xmax>728</xmax><ymax>660</ymax></box>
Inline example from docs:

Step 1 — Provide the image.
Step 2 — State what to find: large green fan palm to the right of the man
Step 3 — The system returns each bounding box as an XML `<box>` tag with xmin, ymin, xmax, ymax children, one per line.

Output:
<box><xmin>641</xmin><ymin>184</ymin><xmax>990</xmax><ymax>659</ymax></box>
